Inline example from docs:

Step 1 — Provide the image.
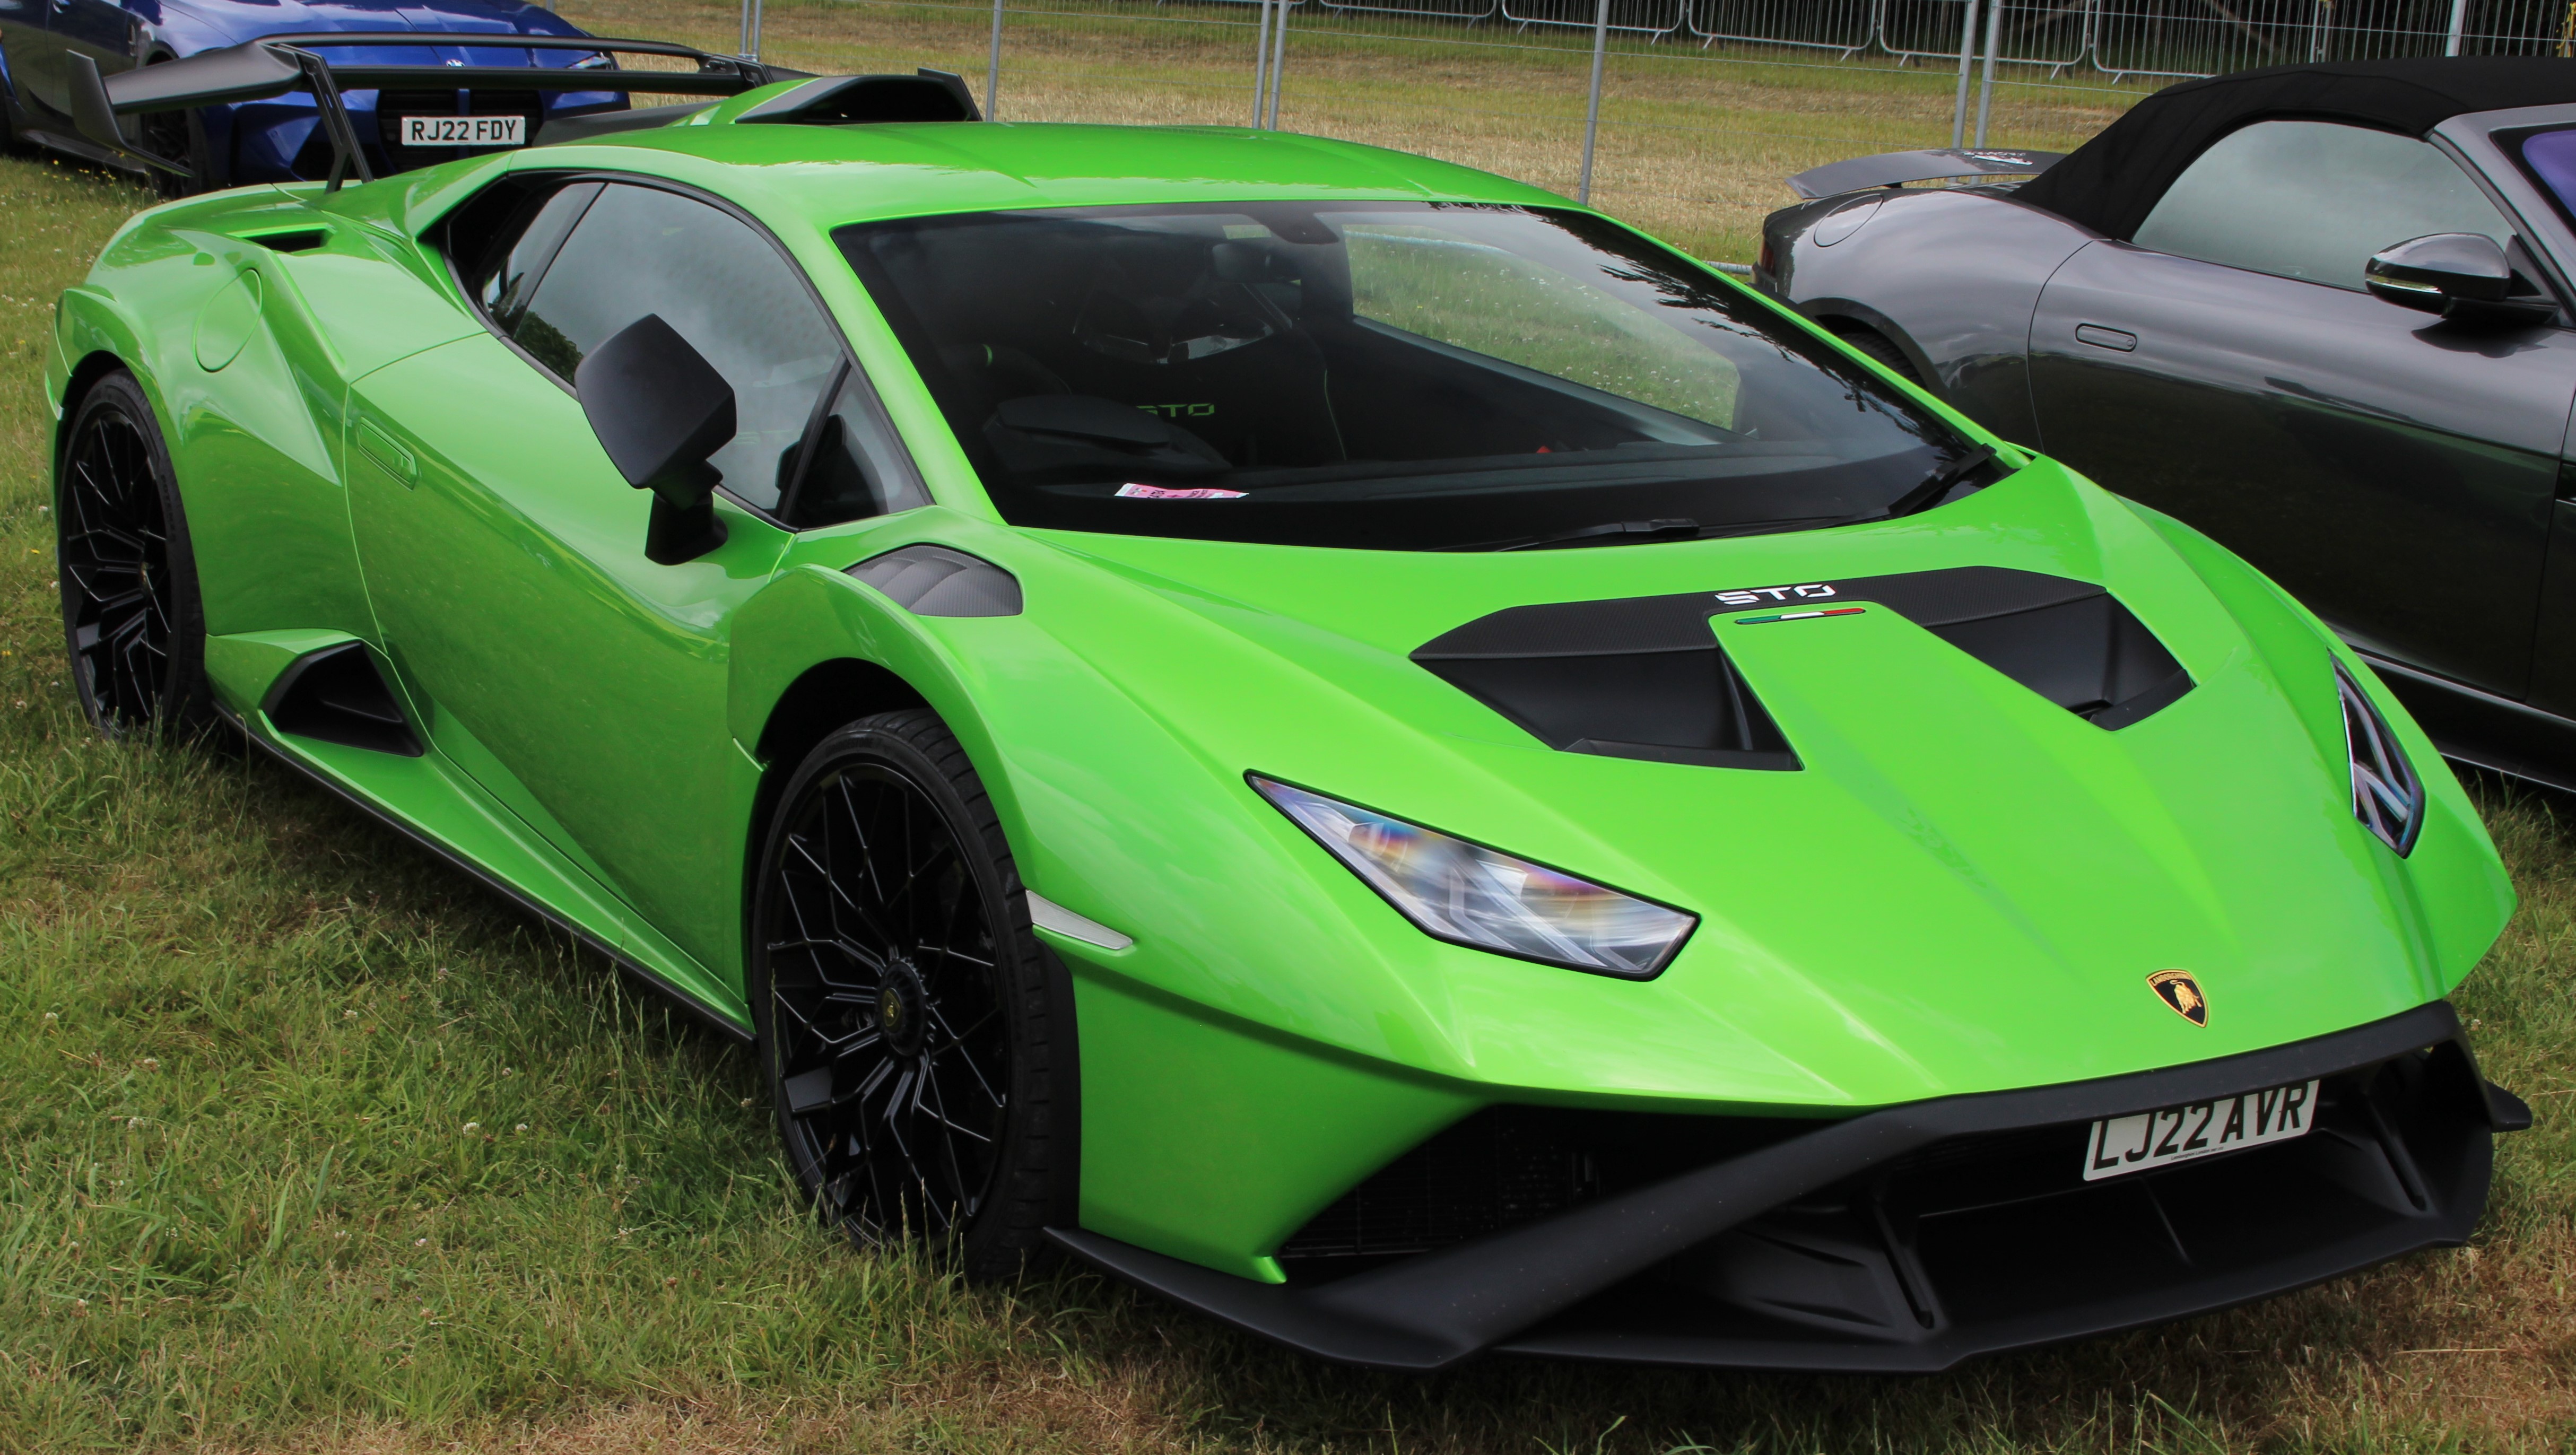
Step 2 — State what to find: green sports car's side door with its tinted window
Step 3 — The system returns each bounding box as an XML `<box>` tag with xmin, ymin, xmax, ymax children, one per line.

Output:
<box><xmin>350</xmin><ymin>180</ymin><xmax>920</xmax><ymax>966</ymax></box>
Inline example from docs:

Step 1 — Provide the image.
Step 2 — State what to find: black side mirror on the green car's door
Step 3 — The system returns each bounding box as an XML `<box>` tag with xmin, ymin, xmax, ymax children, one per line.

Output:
<box><xmin>572</xmin><ymin>314</ymin><xmax>737</xmax><ymax>567</ymax></box>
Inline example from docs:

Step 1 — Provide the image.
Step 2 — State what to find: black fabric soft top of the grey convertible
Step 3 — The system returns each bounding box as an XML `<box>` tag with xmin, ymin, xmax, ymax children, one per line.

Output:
<box><xmin>2012</xmin><ymin>57</ymin><xmax>2576</xmax><ymax>237</ymax></box>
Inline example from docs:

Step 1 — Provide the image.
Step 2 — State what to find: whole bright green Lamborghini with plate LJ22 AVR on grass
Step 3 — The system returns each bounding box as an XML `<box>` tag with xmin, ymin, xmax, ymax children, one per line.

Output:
<box><xmin>46</xmin><ymin>59</ymin><xmax>2530</xmax><ymax>1370</ymax></box>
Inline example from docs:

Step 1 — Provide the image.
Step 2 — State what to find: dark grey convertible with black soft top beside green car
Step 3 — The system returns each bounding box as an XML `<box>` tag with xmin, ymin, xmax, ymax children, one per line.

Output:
<box><xmin>1754</xmin><ymin>57</ymin><xmax>2576</xmax><ymax>788</ymax></box>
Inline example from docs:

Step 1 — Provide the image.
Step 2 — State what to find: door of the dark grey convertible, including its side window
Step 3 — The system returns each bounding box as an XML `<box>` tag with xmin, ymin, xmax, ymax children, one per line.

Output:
<box><xmin>2030</xmin><ymin>121</ymin><xmax>2576</xmax><ymax>698</ymax></box>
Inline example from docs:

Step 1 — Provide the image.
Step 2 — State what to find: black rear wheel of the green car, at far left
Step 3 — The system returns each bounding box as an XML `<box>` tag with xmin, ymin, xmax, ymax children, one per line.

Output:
<box><xmin>54</xmin><ymin>368</ymin><xmax>214</xmax><ymax>736</ymax></box>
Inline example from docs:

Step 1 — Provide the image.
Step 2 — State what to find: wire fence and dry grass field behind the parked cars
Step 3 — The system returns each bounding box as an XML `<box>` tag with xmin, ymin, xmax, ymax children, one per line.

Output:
<box><xmin>562</xmin><ymin>0</ymin><xmax>2576</xmax><ymax>260</ymax></box>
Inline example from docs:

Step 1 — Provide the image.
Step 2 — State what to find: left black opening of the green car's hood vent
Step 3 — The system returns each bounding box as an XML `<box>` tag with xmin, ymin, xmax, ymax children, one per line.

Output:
<box><xmin>1414</xmin><ymin>593</ymin><xmax>1798</xmax><ymax>770</ymax></box>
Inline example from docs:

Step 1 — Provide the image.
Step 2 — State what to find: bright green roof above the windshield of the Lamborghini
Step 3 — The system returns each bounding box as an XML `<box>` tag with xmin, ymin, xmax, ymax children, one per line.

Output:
<box><xmin>538</xmin><ymin>117</ymin><xmax>1566</xmax><ymax>229</ymax></box>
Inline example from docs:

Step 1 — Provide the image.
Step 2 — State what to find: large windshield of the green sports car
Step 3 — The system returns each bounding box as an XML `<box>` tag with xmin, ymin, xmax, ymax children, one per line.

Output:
<box><xmin>834</xmin><ymin>204</ymin><xmax>1973</xmax><ymax>551</ymax></box>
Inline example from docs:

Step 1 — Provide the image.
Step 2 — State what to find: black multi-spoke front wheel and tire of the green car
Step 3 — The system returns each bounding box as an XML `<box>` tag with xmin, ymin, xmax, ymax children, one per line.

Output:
<box><xmin>750</xmin><ymin>711</ymin><xmax>1072</xmax><ymax>1277</ymax></box>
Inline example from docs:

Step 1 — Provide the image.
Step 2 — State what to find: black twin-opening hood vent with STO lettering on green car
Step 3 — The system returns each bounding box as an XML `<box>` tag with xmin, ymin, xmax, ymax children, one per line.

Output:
<box><xmin>1412</xmin><ymin>567</ymin><xmax>2192</xmax><ymax>770</ymax></box>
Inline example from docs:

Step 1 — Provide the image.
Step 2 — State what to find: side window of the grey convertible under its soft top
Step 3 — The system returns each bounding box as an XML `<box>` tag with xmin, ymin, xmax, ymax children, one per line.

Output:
<box><xmin>2133</xmin><ymin>121</ymin><xmax>2514</xmax><ymax>291</ymax></box>
